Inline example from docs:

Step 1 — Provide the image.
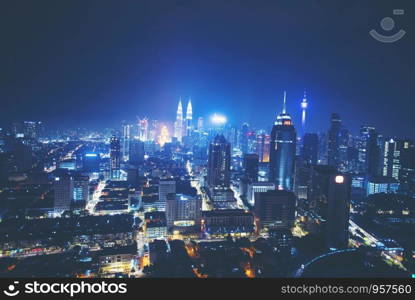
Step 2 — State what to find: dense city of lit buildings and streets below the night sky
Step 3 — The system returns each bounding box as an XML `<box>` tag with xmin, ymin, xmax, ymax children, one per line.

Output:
<box><xmin>0</xmin><ymin>92</ymin><xmax>415</xmax><ymax>278</ymax></box>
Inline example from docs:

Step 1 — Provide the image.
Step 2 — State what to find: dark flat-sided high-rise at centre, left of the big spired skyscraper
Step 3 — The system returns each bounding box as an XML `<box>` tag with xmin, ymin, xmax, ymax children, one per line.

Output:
<box><xmin>207</xmin><ymin>135</ymin><xmax>231</xmax><ymax>187</ymax></box>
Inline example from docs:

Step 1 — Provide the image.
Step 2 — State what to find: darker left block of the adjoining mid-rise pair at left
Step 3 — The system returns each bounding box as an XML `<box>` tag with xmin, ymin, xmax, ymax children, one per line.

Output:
<box><xmin>53</xmin><ymin>175</ymin><xmax>74</xmax><ymax>214</ymax></box>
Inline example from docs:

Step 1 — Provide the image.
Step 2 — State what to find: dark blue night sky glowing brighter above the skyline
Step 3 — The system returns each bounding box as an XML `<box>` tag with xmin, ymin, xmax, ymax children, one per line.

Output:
<box><xmin>0</xmin><ymin>0</ymin><xmax>415</xmax><ymax>138</ymax></box>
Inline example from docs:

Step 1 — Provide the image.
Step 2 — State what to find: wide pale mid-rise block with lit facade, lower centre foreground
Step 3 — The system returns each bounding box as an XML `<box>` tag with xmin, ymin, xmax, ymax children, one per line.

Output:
<box><xmin>166</xmin><ymin>194</ymin><xmax>202</xmax><ymax>229</ymax></box>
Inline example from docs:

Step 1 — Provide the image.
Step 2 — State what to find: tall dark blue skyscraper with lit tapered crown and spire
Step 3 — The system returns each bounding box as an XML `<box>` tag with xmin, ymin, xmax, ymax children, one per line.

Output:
<box><xmin>269</xmin><ymin>92</ymin><xmax>296</xmax><ymax>190</ymax></box>
